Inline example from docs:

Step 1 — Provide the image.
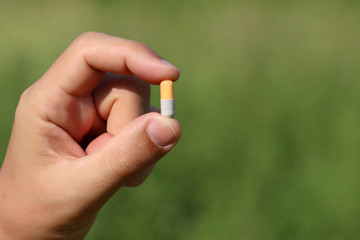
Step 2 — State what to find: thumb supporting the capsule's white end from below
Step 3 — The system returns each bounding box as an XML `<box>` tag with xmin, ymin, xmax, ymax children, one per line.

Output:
<box><xmin>88</xmin><ymin>113</ymin><xmax>181</xmax><ymax>192</ymax></box>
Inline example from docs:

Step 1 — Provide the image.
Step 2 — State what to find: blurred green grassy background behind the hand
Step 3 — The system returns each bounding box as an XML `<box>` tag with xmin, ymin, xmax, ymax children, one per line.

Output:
<box><xmin>0</xmin><ymin>0</ymin><xmax>360</xmax><ymax>240</ymax></box>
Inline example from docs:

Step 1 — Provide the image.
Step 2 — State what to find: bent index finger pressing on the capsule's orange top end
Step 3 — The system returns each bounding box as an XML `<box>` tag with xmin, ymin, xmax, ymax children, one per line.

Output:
<box><xmin>40</xmin><ymin>32</ymin><xmax>180</xmax><ymax>96</ymax></box>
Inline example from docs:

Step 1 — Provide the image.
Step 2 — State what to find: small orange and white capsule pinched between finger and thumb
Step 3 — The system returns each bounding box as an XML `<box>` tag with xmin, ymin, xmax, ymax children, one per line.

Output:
<box><xmin>160</xmin><ymin>80</ymin><xmax>175</xmax><ymax>118</ymax></box>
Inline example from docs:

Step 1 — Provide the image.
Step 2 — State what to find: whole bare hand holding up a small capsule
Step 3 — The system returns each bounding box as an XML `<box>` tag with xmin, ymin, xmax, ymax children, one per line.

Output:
<box><xmin>0</xmin><ymin>32</ymin><xmax>181</xmax><ymax>240</ymax></box>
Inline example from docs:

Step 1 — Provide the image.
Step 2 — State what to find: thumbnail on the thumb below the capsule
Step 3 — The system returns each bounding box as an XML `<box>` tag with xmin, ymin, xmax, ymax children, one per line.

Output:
<box><xmin>146</xmin><ymin>117</ymin><xmax>176</xmax><ymax>147</ymax></box>
